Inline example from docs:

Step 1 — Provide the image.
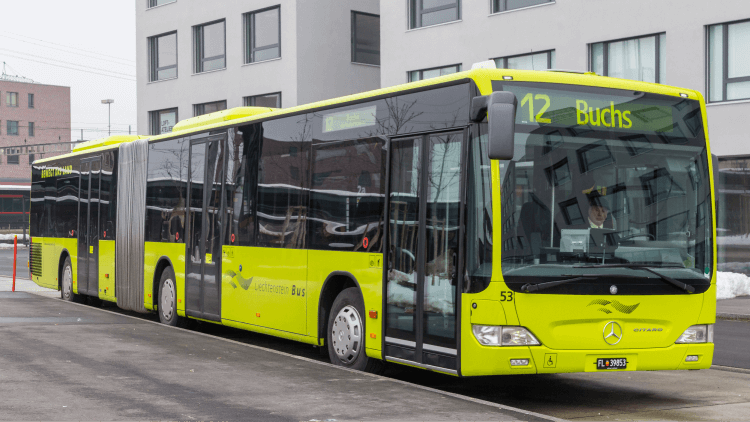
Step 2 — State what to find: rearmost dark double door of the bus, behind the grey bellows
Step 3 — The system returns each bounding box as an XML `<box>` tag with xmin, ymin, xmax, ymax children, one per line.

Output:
<box><xmin>78</xmin><ymin>157</ymin><xmax>102</xmax><ymax>297</ymax></box>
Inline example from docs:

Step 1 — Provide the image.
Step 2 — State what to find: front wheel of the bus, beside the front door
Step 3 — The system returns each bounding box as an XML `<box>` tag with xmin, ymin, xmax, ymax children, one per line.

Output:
<box><xmin>326</xmin><ymin>287</ymin><xmax>385</xmax><ymax>373</ymax></box>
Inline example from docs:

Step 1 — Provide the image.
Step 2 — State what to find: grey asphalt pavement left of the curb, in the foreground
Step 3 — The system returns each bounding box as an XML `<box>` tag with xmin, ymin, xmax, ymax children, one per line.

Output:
<box><xmin>0</xmin><ymin>291</ymin><xmax>551</xmax><ymax>421</ymax></box>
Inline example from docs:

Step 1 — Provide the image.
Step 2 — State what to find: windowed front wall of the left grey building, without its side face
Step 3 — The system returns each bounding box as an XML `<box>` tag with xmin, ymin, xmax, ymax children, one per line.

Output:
<box><xmin>136</xmin><ymin>0</ymin><xmax>297</xmax><ymax>133</ymax></box>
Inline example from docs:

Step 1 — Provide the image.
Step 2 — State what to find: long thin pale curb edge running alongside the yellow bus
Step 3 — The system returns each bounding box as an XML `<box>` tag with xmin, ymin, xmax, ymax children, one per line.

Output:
<box><xmin>25</xmin><ymin>292</ymin><xmax>566</xmax><ymax>422</ymax></box>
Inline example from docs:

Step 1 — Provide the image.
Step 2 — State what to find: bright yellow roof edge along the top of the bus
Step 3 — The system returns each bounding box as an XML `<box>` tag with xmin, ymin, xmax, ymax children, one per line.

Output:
<box><xmin>34</xmin><ymin>69</ymin><xmax>703</xmax><ymax>164</ymax></box>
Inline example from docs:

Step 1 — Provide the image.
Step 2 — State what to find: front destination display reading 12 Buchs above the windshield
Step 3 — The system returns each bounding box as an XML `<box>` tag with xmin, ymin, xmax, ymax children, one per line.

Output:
<box><xmin>502</xmin><ymin>84</ymin><xmax>675</xmax><ymax>134</ymax></box>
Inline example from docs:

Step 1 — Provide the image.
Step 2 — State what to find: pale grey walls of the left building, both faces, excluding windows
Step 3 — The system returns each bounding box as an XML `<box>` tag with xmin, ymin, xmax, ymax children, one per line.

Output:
<box><xmin>135</xmin><ymin>0</ymin><xmax>380</xmax><ymax>134</ymax></box>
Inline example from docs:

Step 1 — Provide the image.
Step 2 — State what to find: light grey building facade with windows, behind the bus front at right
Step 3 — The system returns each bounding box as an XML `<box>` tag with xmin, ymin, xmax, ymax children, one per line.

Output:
<box><xmin>380</xmin><ymin>0</ymin><xmax>750</xmax><ymax>156</ymax></box>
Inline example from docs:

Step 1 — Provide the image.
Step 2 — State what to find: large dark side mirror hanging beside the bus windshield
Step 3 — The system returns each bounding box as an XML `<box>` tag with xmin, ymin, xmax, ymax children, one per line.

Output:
<box><xmin>471</xmin><ymin>91</ymin><xmax>518</xmax><ymax>160</ymax></box>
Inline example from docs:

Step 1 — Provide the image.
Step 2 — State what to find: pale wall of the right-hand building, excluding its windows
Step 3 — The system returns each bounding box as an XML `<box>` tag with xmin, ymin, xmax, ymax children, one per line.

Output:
<box><xmin>380</xmin><ymin>0</ymin><xmax>750</xmax><ymax>155</ymax></box>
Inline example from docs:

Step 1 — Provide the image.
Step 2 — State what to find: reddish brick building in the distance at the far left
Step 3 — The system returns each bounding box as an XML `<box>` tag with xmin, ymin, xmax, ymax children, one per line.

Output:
<box><xmin>0</xmin><ymin>80</ymin><xmax>70</xmax><ymax>185</ymax></box>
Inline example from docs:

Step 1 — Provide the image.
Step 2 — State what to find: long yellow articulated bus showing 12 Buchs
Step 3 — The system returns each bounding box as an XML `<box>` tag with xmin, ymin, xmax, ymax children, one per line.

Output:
<box><xmin>30</xmin><ymin>69</ymin><xmax>716</xmax><ymax>376</ymax></box>
